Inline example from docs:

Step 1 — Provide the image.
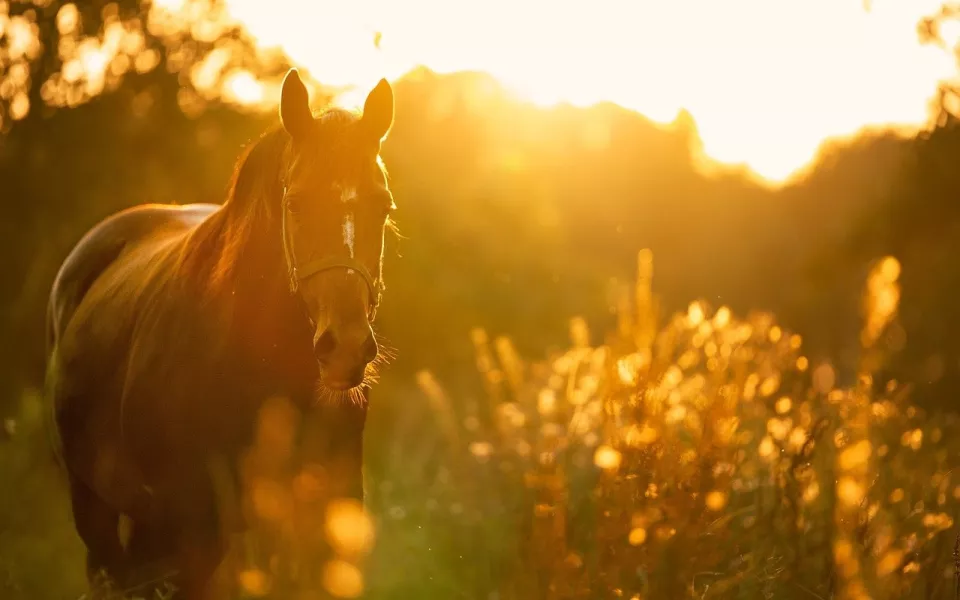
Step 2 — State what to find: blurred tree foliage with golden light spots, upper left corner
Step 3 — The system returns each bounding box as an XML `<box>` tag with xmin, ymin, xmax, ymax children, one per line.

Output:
<box><xmin>0</xmin><ymin>0</ymin><xmax>296</xmax><ymax>132</ymax></box>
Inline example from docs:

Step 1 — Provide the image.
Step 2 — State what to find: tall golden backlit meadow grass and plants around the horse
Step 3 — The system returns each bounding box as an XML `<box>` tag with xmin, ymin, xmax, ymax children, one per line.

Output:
<box><xmin>0</xmin><ymin>252</ymin><xmax>960</xmax><ymax>600</ymax></box>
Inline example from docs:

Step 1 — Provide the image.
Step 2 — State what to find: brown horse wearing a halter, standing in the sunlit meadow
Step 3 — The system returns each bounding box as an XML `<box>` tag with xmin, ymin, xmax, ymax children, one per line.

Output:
<box><xmin>47</xmin><ymin>70</ymin><xmax>394</xmax><ymax>599</ymax></box>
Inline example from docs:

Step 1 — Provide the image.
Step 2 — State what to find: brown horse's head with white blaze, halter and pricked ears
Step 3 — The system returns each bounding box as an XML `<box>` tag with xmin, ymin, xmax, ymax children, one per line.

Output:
<box><xmin>280</xmin><ymin>70</ymin><xmax>395</xmax><ymax>392</ymax></box>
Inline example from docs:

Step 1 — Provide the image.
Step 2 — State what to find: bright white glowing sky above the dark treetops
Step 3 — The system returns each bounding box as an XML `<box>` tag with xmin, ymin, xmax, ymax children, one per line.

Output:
<box><xmin>193</xmin><ymin>0</ymin><xmax>957</xmax><ymax>181</ymax></box>
